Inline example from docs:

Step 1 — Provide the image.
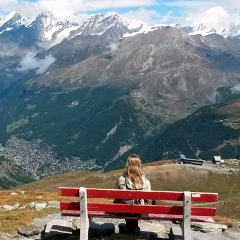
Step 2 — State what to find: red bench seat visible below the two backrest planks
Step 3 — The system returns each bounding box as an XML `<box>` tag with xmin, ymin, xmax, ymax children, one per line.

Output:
<box><xmin>62</xmin><ymin>211</ymin><xmax>214</xmax><ymax>223</ymax></box>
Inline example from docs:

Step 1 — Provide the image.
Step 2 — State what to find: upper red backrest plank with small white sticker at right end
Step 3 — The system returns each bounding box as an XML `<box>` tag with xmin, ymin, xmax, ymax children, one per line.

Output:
<box><xmin>59</xmin><ymin>188</ymin><xmax>218</xmax><ymax>202</ymax></box>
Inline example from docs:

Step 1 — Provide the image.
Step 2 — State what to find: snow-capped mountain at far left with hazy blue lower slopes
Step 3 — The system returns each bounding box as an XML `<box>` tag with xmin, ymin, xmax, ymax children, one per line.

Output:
<box><xmin>0</xmin><ymin>12</ymin><xmax>79</xmax><ymax>85</ymax></box>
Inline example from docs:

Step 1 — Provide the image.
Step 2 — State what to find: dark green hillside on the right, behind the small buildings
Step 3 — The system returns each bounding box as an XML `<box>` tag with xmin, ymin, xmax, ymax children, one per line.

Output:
<box><xmin>106</xmin><ymin>94</ymin><xmax>240</xmax><ymax>171</ymax></box>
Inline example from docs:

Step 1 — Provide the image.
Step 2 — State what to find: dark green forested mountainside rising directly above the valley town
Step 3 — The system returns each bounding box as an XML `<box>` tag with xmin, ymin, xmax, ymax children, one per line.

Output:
<box><xmin>0</xmin><ymin>83</ymin><xmax>159</xmax><ymax>171</ymax></box>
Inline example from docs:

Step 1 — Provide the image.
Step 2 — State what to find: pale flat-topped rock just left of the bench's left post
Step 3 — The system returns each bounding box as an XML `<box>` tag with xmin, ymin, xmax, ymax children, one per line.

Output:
<box><xmin>45</xmin><ymin>220</ymin><xmax>73</xmax><ymax>239</ymax></box>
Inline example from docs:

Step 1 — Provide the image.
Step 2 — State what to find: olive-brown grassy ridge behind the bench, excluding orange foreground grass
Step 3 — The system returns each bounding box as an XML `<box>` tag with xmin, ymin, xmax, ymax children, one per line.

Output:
<box><xmin>13</xmin><ymin>161</ymin><xmax>240</xmax><ymax>219</ymax></box>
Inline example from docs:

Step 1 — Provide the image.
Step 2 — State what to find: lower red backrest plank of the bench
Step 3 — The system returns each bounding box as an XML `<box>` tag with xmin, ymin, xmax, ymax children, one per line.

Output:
<box><xmin>60</xmin><ymin>202</ymin><xmax>216</xmax><ymax>216</ymax></box>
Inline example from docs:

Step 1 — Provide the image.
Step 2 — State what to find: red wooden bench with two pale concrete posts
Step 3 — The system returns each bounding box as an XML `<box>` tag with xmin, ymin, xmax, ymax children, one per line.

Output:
<box><xmin>60</xmin><ymin>187</ymin><xmax>218</xmax><ymax>240</ymax></box>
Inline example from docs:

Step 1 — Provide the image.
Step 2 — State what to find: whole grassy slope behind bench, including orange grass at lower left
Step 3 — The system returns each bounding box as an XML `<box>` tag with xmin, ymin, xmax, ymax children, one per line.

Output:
<box><xmin>0</xmin><ymin>160</ymin><xmax>240</xmax><ymax>231</ymax></box>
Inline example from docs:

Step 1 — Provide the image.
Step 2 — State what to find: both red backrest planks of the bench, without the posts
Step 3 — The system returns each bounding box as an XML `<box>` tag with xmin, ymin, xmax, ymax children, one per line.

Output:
<box><xmin>60</xmin><ymin>188</ymin><xmax>218</xmax><ymax>216</ymax></box>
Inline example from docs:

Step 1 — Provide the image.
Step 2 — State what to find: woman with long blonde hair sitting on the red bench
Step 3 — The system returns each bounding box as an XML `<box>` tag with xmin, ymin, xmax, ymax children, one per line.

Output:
<box><xmin>114</xmin><ymin>154</ymin><xmax>151</xmax><ymax>233</ymax></box>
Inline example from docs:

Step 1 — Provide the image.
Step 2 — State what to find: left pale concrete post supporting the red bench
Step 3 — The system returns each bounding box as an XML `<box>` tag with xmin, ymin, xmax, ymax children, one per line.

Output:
<box><xmin>79</xmin><ymin>187</ymin><xmax>89</xmax><ymax>240</ymax></box>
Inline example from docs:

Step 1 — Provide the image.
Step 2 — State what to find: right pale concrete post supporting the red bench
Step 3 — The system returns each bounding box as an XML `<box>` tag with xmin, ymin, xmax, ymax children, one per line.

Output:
<box><xmin>180</xmin><ymin>191</ymin><xmax>191</xmax><ymax>240</ymax></box>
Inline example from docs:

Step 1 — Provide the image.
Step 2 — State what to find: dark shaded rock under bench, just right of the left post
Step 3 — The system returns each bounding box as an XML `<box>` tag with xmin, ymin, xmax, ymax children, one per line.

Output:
<box><xmin>88</xmin><ymin>222</ymin><xmax>115</xmax><ymax>237</ymax></box>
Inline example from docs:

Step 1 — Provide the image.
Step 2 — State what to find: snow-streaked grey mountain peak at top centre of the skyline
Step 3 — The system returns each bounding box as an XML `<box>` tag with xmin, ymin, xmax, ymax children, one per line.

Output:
<box><xmin>70</xmin><ymin>12</ymin><xmax>144</xmax><ymax>39</ymax></box>
